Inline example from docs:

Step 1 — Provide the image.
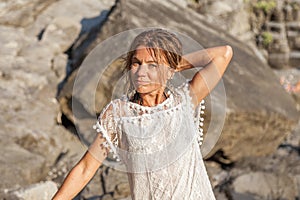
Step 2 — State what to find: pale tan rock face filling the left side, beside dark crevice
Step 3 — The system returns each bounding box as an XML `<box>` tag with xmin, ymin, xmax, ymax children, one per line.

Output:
<box><xmin>0</xmin><ymin>0</ymin><xmax>113</xmax><ymax>195</ymax></box>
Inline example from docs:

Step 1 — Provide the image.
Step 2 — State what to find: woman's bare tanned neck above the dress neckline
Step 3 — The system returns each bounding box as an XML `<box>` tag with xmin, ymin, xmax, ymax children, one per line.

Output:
<box><xmin>139</xmin><ymin>88</ymin><xmax>167</xmax><ymax>107</ymax></box>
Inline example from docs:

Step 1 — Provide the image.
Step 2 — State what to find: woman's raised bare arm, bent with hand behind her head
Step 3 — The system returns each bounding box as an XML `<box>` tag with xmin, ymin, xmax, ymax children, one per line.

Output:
<box><xmin>176</xmin><ymin>45</ymin><xmax>233</xmax><ymax>106</ymax></box>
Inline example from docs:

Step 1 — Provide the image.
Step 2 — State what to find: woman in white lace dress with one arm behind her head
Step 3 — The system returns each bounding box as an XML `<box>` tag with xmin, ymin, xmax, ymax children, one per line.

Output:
<box><xmin>53</xmin><ymin>29</ymin><xmax>232</xmax><ymax>200</ymax></box>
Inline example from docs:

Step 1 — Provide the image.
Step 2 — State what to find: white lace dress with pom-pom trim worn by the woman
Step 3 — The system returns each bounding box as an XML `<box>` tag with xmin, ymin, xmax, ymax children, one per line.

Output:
<box><xmin>90</xmin><ymin>84</ymin><xmax>215</xmax><ymax>200</ymax></box>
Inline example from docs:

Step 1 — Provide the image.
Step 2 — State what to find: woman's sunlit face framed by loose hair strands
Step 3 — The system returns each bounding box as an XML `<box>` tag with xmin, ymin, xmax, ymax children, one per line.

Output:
<box><xmin>130</xmin><ymin>46</ymin><xmax>172</xmax><ymax>93</ymax></box>
